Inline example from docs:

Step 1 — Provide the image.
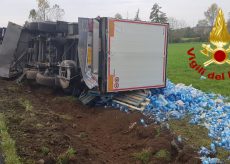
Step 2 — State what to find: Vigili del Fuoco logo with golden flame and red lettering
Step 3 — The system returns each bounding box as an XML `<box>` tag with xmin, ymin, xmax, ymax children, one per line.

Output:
<box><xmin>187</xmin><ymin>9</ymin><xmax>230</xmax><ymax>80</ymax></box>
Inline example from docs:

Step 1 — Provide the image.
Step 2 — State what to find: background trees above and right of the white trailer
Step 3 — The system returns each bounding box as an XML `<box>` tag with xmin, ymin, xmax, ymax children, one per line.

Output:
<box><xmin>115</xmin><ymin>3</ymin><xmax>230</xmax><ymax>43</ymax></box>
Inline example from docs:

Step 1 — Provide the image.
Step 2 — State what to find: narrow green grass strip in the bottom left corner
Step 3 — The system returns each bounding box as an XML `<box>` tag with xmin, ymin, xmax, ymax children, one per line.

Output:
<box><xmin>0</xmin><ymin>114</ymin><xmax>21</xmax><ymax>164</ymax></box>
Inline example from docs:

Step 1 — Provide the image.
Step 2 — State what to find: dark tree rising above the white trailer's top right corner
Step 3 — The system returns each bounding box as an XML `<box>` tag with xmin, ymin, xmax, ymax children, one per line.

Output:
<box><xmin>149</xmin><ymin>3</ymin><xmax>167</xmax><ymax>23</ymax></box>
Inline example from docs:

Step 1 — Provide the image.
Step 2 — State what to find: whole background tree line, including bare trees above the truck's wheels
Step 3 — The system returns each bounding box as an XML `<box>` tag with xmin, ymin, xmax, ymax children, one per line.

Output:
<box><xmin>29</xmin><ymin>0</ymin><xmax>230</xmax><ymax>43</ymax></box>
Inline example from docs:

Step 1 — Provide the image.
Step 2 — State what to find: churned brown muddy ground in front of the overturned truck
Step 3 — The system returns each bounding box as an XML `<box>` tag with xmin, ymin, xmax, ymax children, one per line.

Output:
<box><xmin>0</xmin><ymin>79</ymin><xmax>200</xmax><ymax>164</ymax></box>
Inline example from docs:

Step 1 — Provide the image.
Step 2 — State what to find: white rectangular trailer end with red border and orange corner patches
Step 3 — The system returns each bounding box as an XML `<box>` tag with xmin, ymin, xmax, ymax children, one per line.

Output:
<box><xmin>107</xmin><ymin>19</ymin><xmax>168</xmax><ymax>92</ymax></box>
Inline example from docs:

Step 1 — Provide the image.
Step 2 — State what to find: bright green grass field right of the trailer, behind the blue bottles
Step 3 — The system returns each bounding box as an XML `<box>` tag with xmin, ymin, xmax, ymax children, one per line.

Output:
<box><xmin>167</xmin><ymin>43</ymin><xmax>230</xmax><ymax>96</ymax></box>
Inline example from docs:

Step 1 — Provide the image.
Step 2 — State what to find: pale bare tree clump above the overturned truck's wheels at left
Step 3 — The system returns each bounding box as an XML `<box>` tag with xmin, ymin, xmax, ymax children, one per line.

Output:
<box><xmin>29</xmin><ymin>0</ymin><xmax>65</xmax><ymax>21</ymax></box>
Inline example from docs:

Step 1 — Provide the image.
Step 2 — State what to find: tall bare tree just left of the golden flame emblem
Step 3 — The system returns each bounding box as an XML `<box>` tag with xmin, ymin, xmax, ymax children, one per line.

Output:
<box><xmin>204</xmin><ymin>3</ymin><xmax>218</xmax><ymax>26</ymax></box>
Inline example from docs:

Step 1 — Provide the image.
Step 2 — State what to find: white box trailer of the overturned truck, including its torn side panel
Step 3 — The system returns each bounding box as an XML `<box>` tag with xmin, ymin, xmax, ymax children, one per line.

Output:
<box><xmin>78</xmin><ymin>18</ymin><xmax>168</xmax><ymax>93</ymax></box>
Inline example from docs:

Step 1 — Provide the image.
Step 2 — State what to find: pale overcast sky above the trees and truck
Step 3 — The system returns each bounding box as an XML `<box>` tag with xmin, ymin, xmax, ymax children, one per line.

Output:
<box><xmin>0</xmin><ymin>0</ymin><xmax>230</xmax><ymax>26</ymax></box>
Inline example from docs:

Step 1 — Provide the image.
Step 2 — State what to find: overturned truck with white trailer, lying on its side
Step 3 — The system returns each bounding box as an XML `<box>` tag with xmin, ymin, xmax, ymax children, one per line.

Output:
<box><xmin>0</xmin><ymin>17</ymin><xmax>168</xmax><ymax>107</ymax></box>
